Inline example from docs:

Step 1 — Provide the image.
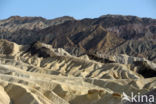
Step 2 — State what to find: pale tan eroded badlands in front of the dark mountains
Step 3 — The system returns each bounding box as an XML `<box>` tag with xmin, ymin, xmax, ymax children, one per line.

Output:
<box><xmin>0</xmin><ymin>40</ymin><xmax>156</xmax><ymax>104</ymax></box>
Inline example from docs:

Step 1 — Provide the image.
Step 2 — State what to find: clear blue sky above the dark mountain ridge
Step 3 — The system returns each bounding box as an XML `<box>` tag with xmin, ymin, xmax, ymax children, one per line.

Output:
<box><xmin>0</xmin><ymin>0</ymin><xmax>156</xmax><ymax>19</ymax></box>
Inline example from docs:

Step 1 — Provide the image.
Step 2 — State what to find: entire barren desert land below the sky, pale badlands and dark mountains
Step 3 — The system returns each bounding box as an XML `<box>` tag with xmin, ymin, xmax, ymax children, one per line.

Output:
<box><xmin>0</xmin><ymin>15</ymin><xmax>156</xmax><ymax>104</ymax></box>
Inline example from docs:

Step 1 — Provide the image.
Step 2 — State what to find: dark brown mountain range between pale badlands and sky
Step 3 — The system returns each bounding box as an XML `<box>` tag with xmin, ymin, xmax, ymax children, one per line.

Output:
<box><xmin>0</xmin><ymin>15</ymin><xmax>156</xmax><ymax>62</ymax></box>
